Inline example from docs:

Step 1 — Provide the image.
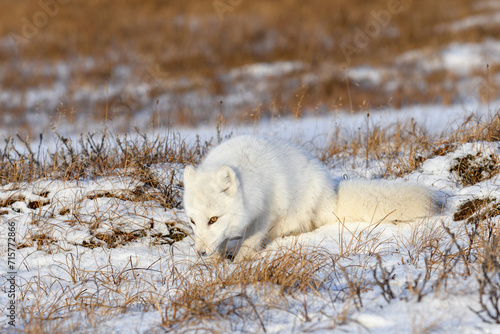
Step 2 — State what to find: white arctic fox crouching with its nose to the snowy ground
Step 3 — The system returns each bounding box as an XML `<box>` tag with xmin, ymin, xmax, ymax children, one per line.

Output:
<box><xmin>184</xmin><ymin>136</ymin><xmax>440</xmax><ymax>261</ymax></box>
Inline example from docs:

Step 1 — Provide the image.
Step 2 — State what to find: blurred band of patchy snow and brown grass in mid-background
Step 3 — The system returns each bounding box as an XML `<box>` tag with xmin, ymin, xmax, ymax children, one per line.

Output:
<box><xmin>0</xmin><ymin>34</ymin><xmax>500</xmax><ymax>136</ymax></box>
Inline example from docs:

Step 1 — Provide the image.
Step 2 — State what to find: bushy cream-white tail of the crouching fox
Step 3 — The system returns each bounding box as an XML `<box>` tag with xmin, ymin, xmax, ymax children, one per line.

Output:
<box><xmin>337</xmin><ymin>180</ymin><xmax>443</xmax><ymax>222</ymax></box>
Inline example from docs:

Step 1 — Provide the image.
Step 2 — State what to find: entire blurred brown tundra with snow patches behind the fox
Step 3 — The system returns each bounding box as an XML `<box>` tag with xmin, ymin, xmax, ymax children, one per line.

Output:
<box><xmin>0</xmin><ymin>0</ymin><xmax>500</xmax><ymax>136</ymax></box>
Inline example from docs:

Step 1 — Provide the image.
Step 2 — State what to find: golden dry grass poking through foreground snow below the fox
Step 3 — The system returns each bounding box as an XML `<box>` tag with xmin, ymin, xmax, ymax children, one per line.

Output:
<box><xmin>7</xmin><ymin>209</ymin><xmax>498</xmax><ymax>333</ymax></box>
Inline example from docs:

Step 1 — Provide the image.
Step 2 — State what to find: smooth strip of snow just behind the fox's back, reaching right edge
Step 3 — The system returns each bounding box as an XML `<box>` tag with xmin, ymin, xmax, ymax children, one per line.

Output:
<box><xmin>175</xmin><ymin>100</ymin><xmax>500</xmax><ymax>152</ymax></box>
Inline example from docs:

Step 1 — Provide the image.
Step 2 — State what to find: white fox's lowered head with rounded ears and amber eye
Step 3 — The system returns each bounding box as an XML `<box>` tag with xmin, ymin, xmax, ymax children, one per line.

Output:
<box><xmin>184</xmin><ymin>166</ymin><xmax>247</xmax><ymax>255</ymax></box>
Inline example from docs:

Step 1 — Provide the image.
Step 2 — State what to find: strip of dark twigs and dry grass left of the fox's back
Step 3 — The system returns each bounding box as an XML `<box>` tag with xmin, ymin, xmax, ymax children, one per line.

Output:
<box><xmin>0</xmin><ymin>128</ymin><xmax>211</xmax><ymax>185</ymax></box>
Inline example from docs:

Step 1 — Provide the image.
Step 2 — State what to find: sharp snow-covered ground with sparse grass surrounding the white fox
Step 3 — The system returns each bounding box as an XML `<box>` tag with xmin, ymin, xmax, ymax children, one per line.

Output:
<box><xmin>0</xmin><ymin>101</ymin><xmax>500</xmax><ymax>333</ymax></box>
